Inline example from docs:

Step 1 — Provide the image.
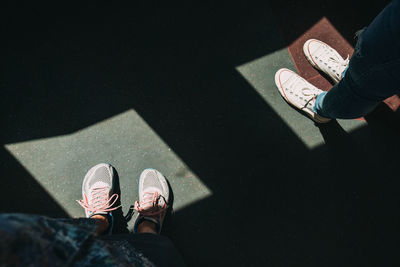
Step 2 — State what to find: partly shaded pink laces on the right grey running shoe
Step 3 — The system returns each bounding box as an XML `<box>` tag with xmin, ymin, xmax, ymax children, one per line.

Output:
<box><xmin>134</xmin><ymin>192</ymin><xmax>168</xmax><ymax>216</ymax></box>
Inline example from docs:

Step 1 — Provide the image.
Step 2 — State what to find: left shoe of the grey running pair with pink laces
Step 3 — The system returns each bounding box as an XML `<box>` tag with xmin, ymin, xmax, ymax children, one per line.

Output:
<box><xmin>77</xmin><ymin>163</ymin><xmax>120</xmax><ymax>233</ymax></box>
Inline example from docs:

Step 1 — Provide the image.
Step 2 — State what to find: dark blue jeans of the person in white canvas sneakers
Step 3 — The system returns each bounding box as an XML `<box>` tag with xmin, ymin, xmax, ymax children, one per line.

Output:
<box><xmin>314</xmin><ymin>0</ymin><xmax>400</xmax><ymax>119</ymax></box>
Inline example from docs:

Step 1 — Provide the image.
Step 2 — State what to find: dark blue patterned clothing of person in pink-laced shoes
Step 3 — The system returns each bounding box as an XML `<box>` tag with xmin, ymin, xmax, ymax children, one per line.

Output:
<box><xmin>0</xmin><ymin>214</ymin><xmax>159</xmax><ymax>266</ymax></box>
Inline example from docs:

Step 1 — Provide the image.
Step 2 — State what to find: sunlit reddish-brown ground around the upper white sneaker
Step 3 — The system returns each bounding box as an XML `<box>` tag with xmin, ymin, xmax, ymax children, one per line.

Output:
<box><xmin>288</xmin><ymin>17</ymin><xmax>400</xmax><ymax>111</ymax></box>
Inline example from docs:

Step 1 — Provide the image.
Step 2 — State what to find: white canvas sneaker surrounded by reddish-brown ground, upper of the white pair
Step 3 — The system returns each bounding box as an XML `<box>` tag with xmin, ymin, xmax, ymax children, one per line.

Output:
<box><xmin>303</xmin><ymin>39</ymin><xmax>350</xmax><ymax>83</ymax></box>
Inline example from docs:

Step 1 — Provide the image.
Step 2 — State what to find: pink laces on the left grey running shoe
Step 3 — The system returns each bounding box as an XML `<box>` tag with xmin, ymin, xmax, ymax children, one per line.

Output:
<box><xmin>77</xmin><ymin>187</ymin><xmax>121</xmax><ymax>217</ymax></box>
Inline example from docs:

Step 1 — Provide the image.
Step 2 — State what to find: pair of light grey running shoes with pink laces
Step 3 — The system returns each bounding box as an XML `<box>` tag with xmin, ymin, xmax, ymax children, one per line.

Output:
<box><xmin>78</xmin><ymin>163</ymin><xmax>169</xmax><ymax>236</ymax></box>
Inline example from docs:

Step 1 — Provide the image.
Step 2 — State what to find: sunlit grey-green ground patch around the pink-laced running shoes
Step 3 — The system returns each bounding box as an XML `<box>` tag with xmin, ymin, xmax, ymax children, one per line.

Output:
<box><xmin>6</xmin><ymin>110</ymin><xmax>212</xmax><ymax>229</ymax></box>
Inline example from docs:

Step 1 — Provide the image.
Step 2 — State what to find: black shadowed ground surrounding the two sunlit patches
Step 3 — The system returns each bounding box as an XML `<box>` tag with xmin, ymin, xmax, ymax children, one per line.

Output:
<box><xmin>0</xmin><ymin>1</ymin><xmax>399</xmax><ymax>266</ymax></box>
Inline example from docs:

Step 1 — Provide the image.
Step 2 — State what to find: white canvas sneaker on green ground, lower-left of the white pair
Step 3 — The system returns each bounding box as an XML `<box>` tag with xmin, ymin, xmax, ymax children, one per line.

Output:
<box><xmin>275</xmin><ymin>69</ymin><xmax>330</xmax><ymax>123</ymax></box>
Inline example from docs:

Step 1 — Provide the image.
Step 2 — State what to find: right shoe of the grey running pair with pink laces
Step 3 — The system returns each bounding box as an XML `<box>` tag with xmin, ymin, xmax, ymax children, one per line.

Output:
<box><xmin>133</xmin><ymin>169</ymin><xmax>169</xmax><ymax>234</ymax></box>
